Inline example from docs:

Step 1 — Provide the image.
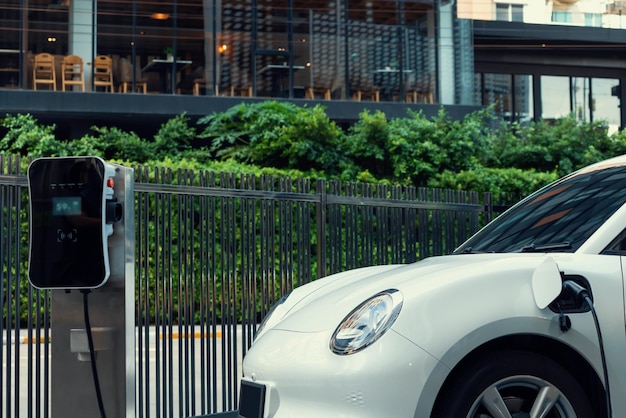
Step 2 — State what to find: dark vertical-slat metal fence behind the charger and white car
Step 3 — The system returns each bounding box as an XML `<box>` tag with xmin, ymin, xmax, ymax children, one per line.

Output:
<box><xmin>0</xmin><ymin>157</ymin><xmax>504</xmax><ymax>418</ymax></box>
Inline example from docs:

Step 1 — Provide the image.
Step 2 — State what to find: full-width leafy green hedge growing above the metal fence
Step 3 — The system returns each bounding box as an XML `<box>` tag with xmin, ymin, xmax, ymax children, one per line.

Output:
<box><xmin>0</xmin><ymin>101</ymin><xmax>626</xmax><ymax>199</ymax></box>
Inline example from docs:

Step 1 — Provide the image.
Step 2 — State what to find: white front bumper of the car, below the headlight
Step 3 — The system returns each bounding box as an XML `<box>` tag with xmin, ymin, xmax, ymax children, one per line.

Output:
<box><xmin>239</xmin><ymin>330</ymin><xmax>437</xmax><ymax>418</ymax></box>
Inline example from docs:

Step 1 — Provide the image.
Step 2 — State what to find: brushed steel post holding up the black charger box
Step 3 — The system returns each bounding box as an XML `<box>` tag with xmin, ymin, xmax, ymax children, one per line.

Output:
<box><xmin>51</xmin><ymin>164</ymin><xmax>135</xmax><ymax>418</ymax></box>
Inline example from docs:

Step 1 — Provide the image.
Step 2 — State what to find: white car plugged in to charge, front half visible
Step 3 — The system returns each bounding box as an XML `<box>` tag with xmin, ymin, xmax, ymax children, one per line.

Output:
<box><xmin>239</xmin><ymin>156</ymin><xmax>626</xmax><ymax>418</ymax></box>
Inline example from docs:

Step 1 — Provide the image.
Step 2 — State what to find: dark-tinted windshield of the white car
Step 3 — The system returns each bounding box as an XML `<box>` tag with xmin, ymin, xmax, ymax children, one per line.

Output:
<box><xmin>454</xmin><ymin>160</ymin><xmax>626</xmax><ymax>254</ymax></box>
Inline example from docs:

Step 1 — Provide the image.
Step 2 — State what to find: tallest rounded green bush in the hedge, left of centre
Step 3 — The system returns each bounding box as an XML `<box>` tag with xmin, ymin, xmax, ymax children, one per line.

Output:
<box><xmin>198</xmin><ymin>101</ymin><xmax>349</xmax><ymax>175</ymax></box>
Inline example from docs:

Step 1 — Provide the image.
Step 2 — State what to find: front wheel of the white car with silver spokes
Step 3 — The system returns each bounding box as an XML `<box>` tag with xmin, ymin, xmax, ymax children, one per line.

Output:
<box><xmin>432</xmin><ymin>351</ymin><xmax>594</xmax><ymax>418</ymax></box>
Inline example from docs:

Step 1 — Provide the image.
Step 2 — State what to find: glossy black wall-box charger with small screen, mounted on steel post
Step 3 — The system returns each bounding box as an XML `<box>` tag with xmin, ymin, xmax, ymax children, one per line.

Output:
<box><xmin>28</xmin><ymin>157</ymin><xmax>109</xmax><ymax>289</ymax></box>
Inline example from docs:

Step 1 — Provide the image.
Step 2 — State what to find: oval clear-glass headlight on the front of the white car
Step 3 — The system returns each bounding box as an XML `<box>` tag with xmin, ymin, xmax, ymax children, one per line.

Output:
<box><xmin>330</xmin><ymin>289</ymin><xmax>403</xmax><ymax>355</ymax></box>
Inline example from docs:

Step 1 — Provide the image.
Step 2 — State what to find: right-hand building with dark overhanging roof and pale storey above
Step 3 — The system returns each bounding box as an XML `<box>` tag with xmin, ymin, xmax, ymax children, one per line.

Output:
<box><xmin>464</xmin><ymin>0</ymin><xmax>626</xmax><ymax>131</ymax></box>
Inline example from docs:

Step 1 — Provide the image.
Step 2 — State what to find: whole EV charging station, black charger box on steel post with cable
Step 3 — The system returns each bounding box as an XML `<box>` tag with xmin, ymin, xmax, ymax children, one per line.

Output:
<box><xmin>28</xmin><ymin>156</ymin><xmax>135</xmax><ymax>418</ymax></box>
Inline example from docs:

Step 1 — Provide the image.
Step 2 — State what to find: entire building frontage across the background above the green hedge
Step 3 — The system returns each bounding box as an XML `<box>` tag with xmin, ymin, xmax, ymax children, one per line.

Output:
<box><xmin>0</xmin><ymin>0</ymin><xmax>626</xmax><ymax>136</ymax></box>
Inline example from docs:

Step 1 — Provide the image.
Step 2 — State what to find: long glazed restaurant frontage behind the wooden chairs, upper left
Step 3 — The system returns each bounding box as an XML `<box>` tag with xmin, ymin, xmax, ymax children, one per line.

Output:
<box><xmin>7</xmin><ymin>0</ymin><xmax>437</xmax><ymax>97</ymax></box>
